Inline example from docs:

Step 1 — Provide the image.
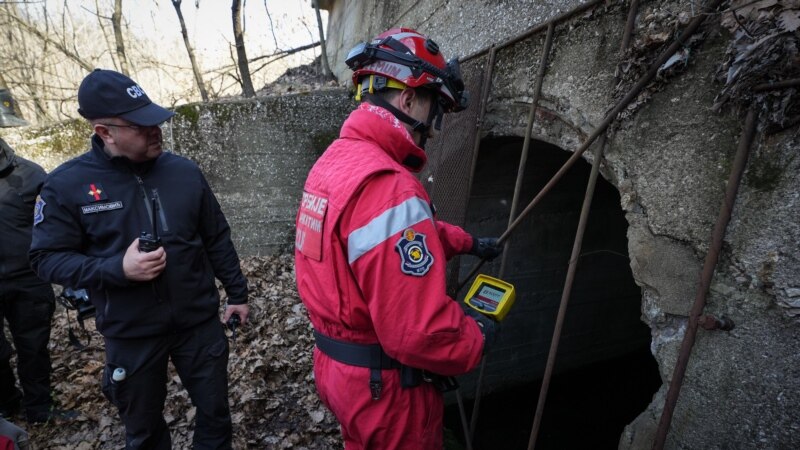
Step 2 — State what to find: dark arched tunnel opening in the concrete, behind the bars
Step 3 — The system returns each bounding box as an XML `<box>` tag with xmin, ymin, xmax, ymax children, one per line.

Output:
<box><xmin>445</xmin><ymin>137</ymin><xmax>661</xmax><ymax>449</ymax></box>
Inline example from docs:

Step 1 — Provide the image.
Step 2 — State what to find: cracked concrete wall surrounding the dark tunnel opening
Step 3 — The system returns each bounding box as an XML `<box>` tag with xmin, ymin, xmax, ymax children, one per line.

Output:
<box><xmin>329</xmin><ymin>0</ymin><xmax>800</xmax><ymax>448</ymax></box>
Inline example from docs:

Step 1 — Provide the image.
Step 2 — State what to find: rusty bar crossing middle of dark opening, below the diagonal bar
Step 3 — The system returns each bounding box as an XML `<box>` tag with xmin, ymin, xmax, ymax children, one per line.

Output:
<box><xmin>528</xmin><ymin>134</ymin><xmax>606</xmax><ymax>450</ymax></box>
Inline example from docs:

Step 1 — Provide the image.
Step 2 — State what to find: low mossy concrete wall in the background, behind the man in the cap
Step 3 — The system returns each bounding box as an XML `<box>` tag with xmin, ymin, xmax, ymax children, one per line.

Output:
<box><xmin>3</xmin><ymin>90</ymin><xmax>355</xmax><ymax>256</ymax></box>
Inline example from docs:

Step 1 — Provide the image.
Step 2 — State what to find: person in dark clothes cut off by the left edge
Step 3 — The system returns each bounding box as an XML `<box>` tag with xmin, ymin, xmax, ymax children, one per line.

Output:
<box><xmin>0</xmin><ymin>89</ymin><xmax>75</xmax><ymax>423</ymax></box>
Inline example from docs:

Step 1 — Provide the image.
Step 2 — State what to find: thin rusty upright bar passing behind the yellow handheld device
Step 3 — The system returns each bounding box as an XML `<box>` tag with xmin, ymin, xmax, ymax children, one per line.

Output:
<box><xmin>469</xmin><ymin>22</ymin><xmax>555</xmax><ymax>447</ymax></box>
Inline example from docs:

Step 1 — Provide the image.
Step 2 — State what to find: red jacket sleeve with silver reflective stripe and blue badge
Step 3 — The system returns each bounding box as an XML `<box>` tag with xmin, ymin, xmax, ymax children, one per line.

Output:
<box><xmin>340</xmin><ymin>174</ymin><xmax>483</xmax><ymax>376</ymax></box>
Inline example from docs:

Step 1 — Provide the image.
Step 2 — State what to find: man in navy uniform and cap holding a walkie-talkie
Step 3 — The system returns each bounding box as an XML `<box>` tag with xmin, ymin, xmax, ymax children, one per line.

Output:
<box><xmin>30</xmin><ymin>69</ymin><xmax>248</xmax><ymax>449</ymax></box>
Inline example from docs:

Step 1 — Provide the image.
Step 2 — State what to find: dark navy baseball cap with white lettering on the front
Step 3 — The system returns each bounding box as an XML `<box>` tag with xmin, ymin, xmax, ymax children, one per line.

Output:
<box><xmin>78</xmin><ymin>69</ymin><xmax>175</xmax><ymax>127</ymax></box>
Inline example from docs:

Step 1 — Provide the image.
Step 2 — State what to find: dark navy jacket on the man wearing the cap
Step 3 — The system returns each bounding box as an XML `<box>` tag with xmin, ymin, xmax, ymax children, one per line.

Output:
<box><xmin>30</xmin><ymin>136</ymin><xmax>247</xmax><ymax>338</ymax></box>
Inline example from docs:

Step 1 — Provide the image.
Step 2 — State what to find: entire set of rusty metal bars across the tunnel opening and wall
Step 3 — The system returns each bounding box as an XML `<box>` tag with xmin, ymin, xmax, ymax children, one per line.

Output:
<box><xmin>422</xmin><ymin>0</ymin><xmax>772</xmax><ymax>450</ymax></box>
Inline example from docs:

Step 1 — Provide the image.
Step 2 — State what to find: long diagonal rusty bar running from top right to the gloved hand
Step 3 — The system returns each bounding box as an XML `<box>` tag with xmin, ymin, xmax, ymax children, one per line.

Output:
<box><xmin>458</xmin><ymin>0</ymin><xmax>723</xmax><ymax>290</ymax></box>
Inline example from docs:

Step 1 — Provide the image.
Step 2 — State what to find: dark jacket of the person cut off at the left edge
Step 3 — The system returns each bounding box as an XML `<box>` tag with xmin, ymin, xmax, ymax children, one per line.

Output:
<box><xmin>0</xmin><ymin>139</ymin><xmax>47</xmax><ymax>279</ymax></box>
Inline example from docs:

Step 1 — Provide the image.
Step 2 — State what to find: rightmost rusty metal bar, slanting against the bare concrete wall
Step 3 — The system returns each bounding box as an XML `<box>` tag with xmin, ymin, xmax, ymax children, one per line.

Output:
<box><xmin>653</xmin><ymin>105</ymin><xmax>758</xmax><ymax>450</ymax></box>
